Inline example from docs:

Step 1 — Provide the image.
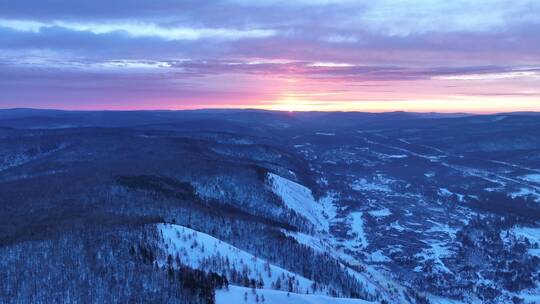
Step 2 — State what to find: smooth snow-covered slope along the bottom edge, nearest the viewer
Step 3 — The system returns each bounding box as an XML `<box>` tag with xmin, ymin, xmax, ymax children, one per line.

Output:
<box><xmin>216</xmin><ymin>285</ymin><xmax>374</xmax><ymax>304</ymax></box>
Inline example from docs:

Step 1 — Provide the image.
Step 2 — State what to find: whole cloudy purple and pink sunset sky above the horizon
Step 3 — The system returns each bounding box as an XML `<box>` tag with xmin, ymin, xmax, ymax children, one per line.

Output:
<box><xmin>0</xmin><ymin>0</ymin><xmax>540</xmax><ymax>113</ymax></box>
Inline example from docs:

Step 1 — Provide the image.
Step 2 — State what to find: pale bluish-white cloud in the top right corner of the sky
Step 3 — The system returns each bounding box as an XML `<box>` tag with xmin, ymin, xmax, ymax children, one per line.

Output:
<box><xmin>354</xmin><ymin>0</ymin><xmax>540</xmax><ymax>36</ymax></box>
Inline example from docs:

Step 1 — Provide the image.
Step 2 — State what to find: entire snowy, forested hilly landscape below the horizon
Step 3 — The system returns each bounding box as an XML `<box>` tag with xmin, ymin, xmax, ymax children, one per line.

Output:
<box><xmin>0</xmin><ymin>111</ymin><xmax>540</xmax><ymax>304</ymax></box>
